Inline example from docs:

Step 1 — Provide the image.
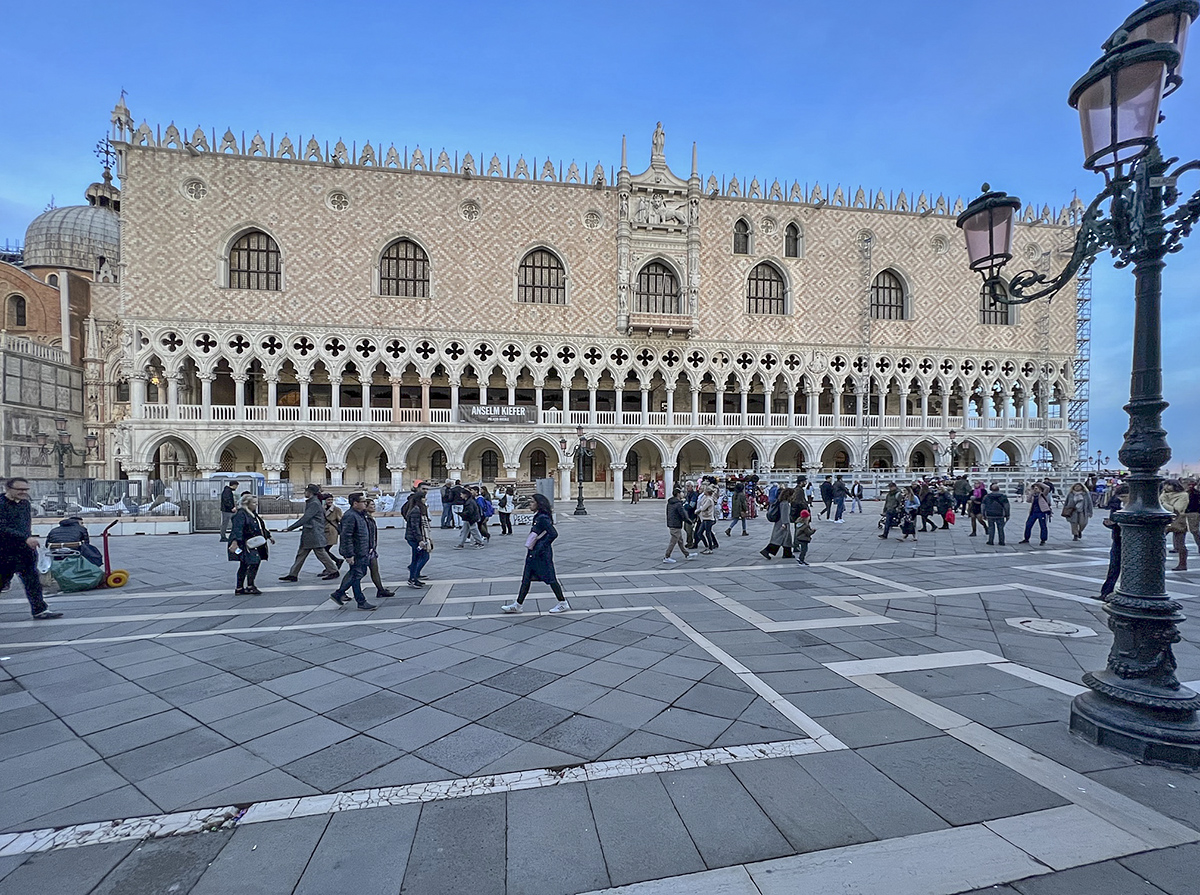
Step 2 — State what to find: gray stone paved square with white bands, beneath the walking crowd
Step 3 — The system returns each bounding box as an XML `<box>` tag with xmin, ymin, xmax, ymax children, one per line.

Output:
<box><xmin>0</xmin><ymin>501</ymin><xmax>1200</xmax><ymax>895</ymax></box>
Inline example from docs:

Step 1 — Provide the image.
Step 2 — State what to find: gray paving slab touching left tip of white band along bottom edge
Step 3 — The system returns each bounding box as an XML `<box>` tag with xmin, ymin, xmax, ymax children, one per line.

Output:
<box><xmin>586</xmin><ymin>775</ymin><xmax>706</xmax><ymax>885</ymax></box>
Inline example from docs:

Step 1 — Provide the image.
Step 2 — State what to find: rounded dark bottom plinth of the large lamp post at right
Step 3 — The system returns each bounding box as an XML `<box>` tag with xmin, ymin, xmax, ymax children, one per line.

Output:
<box><xmin>1070</xmin><ymin>691</ymin><xmax>1200</xmax><ymax>768</ymax></box>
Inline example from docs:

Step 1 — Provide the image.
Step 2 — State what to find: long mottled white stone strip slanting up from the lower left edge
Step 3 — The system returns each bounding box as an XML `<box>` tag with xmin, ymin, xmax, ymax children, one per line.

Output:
<box><xmin>0</xmin><ymin>739</ymin><xmax>824</xmax><ymax>858</ymax></box>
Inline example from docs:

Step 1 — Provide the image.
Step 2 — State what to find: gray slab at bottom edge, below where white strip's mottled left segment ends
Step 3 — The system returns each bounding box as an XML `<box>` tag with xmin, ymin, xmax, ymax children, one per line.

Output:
<box><xmin>188</xmin><ymin>815</ymin><xmax>329</xmax><ymax>895</ymax></box>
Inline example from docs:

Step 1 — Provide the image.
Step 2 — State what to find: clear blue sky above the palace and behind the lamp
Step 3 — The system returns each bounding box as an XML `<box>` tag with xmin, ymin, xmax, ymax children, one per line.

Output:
<box><xmin>0</xmin><ymin>0</ymin><xmax>1200</xmax><ymax>470</ymax></box>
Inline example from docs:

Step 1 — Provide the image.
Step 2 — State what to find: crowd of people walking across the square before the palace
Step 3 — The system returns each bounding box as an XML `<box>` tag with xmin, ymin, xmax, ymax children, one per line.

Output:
<box><xmin>9</xmin><ymin>467</ymin><xmax>1200</xmax><ymax>619</ymax></box>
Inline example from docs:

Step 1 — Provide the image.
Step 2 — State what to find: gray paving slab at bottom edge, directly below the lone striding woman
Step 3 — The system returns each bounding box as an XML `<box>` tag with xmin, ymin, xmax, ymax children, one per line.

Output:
<box><xmin>505</xmin><ymin>786</ymin><xmax>610</xmax><ymax>895</ymax></box>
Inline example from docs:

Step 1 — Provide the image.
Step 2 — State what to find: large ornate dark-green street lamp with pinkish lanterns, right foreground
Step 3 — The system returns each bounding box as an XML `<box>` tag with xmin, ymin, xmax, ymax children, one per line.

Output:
<box><xmin>958</xmin><ymin>0</ymin><xmax>1200</xmax><ymax>767</ymax></box>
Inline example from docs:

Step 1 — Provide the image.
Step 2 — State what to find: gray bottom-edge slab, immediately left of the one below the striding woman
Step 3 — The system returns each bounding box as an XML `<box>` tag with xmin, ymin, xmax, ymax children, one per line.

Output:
<box><xmin>400</xmin><ymin>794</ymin><xmax>506</xmax><ymax>895</ymax></box>
